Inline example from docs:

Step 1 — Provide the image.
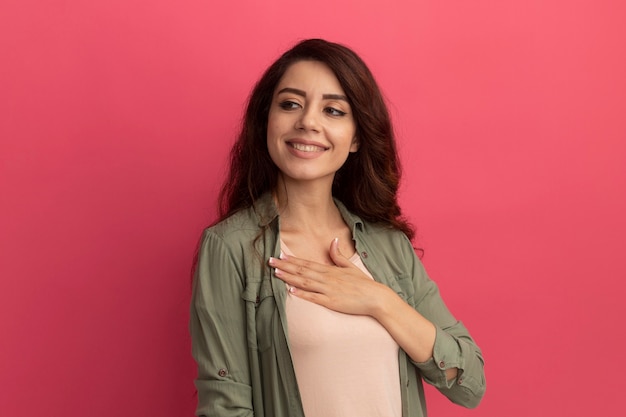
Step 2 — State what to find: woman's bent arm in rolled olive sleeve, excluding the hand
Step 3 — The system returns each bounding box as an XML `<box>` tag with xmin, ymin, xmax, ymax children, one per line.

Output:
<box><xmin>372</xmin><ymin>234</ymin><xmax>485</xmax><ymax>407</ymax></box>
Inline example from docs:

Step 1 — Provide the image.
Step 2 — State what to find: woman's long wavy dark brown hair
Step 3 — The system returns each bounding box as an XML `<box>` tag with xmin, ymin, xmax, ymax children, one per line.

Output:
<box><xmin>219</xmin><ymin>39</ymin><xmax>415</xmax><ymax>239</ymax></box>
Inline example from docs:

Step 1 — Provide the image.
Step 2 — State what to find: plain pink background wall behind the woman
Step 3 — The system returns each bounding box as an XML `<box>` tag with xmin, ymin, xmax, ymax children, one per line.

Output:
<box><xmin>0</xmin><ymin>0</ymin><xmax>626</xmax><ymax>417</ymax></box>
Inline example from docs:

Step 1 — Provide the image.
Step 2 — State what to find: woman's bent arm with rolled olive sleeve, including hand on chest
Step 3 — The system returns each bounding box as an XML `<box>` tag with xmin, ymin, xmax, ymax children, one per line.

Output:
<box><xmin>270</xmin><ymin>235</ymin><xmax>485</xmax><ymax>407</ymax></box>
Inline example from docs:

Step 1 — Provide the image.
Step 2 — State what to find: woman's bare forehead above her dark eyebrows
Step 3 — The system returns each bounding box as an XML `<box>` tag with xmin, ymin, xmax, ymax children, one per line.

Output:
<box><xmin>275</xmin><ymin>61</ymin><xmax>344</xmax><ymax>94</ymax></box>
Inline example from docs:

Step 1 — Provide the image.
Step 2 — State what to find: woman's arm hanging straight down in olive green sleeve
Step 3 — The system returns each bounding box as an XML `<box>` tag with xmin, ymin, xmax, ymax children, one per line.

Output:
<box><xmin>189</xmin><ymin>231</ymin><xmax>253</xmax><ymax>417</ymax></box>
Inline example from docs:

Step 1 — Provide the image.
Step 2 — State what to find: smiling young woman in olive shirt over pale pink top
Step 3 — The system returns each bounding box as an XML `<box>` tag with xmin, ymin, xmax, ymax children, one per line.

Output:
<box><xmin>190</xmin><ymin>39</ymin><xmax>485</xmax><ymax>417</ymax></box>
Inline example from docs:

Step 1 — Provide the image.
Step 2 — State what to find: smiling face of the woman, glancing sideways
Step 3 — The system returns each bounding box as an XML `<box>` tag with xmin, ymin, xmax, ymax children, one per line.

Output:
<box><xmin>267</xmin><ymin>61</ymin><xmax>357</xmax><ymax>183</ymax></box>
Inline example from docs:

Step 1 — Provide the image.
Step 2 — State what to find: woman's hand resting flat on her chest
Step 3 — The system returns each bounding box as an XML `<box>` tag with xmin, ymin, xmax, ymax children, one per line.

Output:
<box><xmin>269</xmin><ymin>239</ymin><xmax>395</xmax><ymax>316</ymax></box>
